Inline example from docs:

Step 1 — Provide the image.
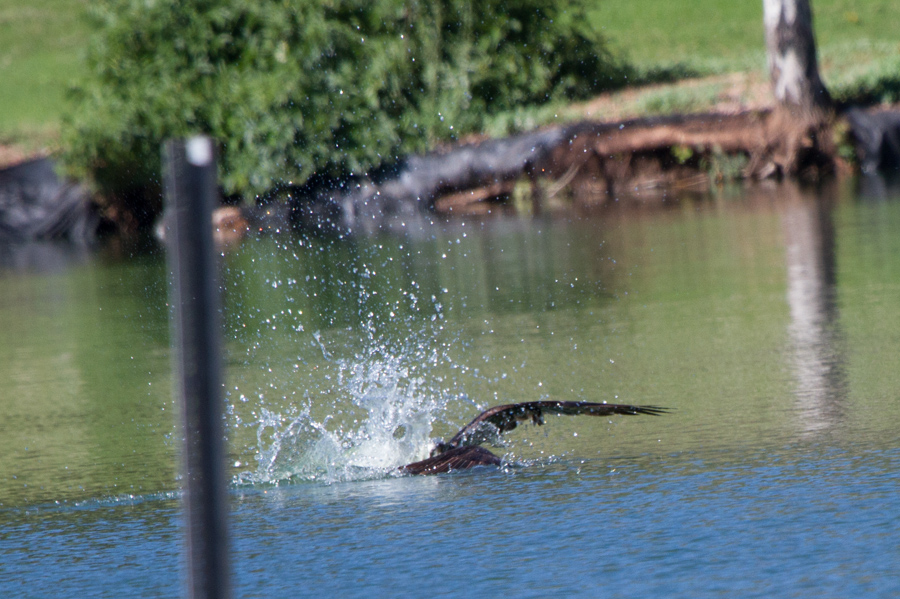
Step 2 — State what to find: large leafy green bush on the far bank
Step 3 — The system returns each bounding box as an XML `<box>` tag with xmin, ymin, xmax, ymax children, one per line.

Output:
<box><xmin>64</xmin><ymin>0</ymin><xmax>621</xmax><ymax>205</ymax></box>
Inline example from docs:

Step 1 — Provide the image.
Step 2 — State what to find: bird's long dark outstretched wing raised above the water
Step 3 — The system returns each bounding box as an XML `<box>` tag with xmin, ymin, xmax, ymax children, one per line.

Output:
<box><xmin>444</xmin><ymin>401</ymin><xmax>668</xmax><ymax>448</ymax></box>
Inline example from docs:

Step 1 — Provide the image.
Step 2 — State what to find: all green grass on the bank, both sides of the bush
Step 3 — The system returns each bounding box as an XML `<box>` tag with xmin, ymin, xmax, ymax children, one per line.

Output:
<box><xmin>0</xmin><ymin>0</ymin><xmax>900</xmax><ymax>164</ymax></box>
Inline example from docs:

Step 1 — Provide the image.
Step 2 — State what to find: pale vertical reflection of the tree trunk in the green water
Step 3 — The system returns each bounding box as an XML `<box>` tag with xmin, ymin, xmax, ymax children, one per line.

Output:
<box><xmin>779</xmin><ymin>183</ymin><xmax>847</xmax><ymax>434</ymax></box>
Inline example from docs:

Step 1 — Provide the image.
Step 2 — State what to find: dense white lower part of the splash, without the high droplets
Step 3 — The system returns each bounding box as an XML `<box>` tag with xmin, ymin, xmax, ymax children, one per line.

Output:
<box><xmin>236</xmin><ymin>335</ymin><xmax>454</xmax><ymax>484</ymax></box>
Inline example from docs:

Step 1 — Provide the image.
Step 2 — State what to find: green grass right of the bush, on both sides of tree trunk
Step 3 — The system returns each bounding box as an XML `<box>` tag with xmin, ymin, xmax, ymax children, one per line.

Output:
<box><xmin>591</xmin><ymin>0</ymin><xmax>900</xmax><ymax>88</ymax></box>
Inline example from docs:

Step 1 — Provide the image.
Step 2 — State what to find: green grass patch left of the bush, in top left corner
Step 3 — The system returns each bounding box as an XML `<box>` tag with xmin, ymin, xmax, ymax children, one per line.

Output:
<box><xmin>0</xmin><ymin>0</ymin><xmax>89</xmax><ymax>147</ymax></box>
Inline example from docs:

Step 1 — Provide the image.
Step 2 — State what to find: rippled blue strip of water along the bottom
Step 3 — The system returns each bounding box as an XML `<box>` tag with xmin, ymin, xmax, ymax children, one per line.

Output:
<box><xmin>0</xmin><ymin>446</ymin><xmax>900</xmax><ymax>597</ymax></box>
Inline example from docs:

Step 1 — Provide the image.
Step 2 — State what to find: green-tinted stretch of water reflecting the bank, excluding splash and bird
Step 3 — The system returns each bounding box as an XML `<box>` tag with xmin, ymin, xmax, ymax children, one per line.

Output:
<box><xmin>0</xmin><ymin>181</ymin><xmax>900</xmax><ymax>508</ymax></box>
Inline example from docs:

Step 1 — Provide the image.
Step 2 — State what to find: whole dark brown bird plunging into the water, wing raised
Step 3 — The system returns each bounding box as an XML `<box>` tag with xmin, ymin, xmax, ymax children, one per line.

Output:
<box><xmin>399</xmin><ymin>400</ymin><xmax>669</xmax><ymax>474</ymax></box>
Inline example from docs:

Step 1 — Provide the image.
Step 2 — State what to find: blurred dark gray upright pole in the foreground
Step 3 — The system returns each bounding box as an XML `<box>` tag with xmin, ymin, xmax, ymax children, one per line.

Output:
<box><xmin>163</xmin><ymin>137</ymin><xmax>231</xmax><ymax>599</ymax></box>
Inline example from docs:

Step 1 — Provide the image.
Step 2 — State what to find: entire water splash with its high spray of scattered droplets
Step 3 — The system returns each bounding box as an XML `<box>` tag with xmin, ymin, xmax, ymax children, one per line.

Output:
<box><xmin>229</xmin><ymin>240</ymin><xmax>471</xmax><ymax>484</ymax></box>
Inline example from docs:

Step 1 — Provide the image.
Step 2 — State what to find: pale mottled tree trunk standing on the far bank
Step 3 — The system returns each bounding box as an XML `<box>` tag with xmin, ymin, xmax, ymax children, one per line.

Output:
<box><xmin>763</xmin><ymin>0</ymin><xmax>831</xmax><ymax>116</ymax></box>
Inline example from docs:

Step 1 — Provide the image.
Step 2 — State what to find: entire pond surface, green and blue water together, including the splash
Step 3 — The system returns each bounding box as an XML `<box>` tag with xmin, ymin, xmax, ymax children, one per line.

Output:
<box><xmin>0</xmin><ymin>181</ymin><xmax>900</xmax><ymax>597</ymax></box>
